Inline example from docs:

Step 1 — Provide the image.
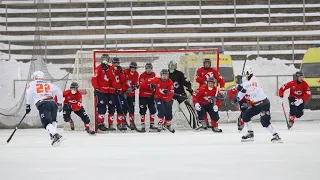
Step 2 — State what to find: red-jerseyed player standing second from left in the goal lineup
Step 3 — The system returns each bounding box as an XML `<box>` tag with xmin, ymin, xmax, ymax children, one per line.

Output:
<box><xmin>108</xmin><ymin>57</ymin><xmax>127</xmax><ymax>131</ymax></box>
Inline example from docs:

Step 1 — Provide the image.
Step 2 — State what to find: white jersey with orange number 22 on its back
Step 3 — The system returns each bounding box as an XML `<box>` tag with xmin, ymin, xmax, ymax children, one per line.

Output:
<box><xmin>26</xmin><ymin>80</ymin><xmax>63</xmax><ymax>104</ymax></box>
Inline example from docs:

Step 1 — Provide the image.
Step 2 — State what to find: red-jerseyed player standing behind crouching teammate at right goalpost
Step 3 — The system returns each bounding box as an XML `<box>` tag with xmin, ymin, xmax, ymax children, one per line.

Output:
<box><xmin>196</xmin><ymin>58</ymin><xmax>226</xmax><ymax>125</ymax></box>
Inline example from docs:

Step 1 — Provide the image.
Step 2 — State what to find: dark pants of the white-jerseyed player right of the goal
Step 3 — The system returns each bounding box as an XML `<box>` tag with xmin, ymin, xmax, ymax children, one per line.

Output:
<box><xmin>242</xmin><ymin>98</ymin><xmax>271</xmax><ymax>127</ymax></box>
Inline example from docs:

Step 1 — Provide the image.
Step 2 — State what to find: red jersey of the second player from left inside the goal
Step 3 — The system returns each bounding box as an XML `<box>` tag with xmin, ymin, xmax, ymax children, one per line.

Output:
<box><xmin>109</xmin><ymin>66</ymin><xmax>125</xmax><ymax>94</ymax></box>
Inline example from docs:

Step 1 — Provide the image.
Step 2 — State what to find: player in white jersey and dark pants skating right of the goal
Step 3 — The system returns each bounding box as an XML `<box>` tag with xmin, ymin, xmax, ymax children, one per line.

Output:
<box><xmin>237</xmin><ymin>67</ymin><xmax>282</xmax><ymax>143</ymax></box>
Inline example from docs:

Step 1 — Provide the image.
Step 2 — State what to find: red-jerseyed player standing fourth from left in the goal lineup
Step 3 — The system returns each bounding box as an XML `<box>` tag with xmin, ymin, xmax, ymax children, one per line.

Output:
<box><xmin>139</xmin><ymin>63</ymin><xmax>158</xmax><ymax>131</ymax></box>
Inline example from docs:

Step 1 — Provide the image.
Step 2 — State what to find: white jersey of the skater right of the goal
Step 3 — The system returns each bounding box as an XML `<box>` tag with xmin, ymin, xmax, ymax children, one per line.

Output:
<box><xmin>238</xmin><ymin>76</ymin><xmax>267</xmax><ymax>103</ymax></box>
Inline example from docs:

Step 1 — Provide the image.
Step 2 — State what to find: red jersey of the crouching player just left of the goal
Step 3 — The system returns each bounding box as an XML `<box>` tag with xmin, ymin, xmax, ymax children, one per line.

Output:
<box><xmin>63</xmin><ymin>89</ymin><xmax>82</xmax><ymax>111</ymax></box>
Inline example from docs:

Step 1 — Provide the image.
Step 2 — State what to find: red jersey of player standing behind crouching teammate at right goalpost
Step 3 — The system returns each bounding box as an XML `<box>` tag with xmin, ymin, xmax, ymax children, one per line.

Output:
<box><xmin>196</xmin><ymin>67</ymin><xmax>225</xmax><ymax>88</ymax></box>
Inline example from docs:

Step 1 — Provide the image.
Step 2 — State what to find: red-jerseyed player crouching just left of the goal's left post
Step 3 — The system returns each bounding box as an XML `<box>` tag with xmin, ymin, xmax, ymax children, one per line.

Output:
<box><xmin>63</xmin><ymin>82</ymin><xmax>95</xmax><ymax>135</ymax></box>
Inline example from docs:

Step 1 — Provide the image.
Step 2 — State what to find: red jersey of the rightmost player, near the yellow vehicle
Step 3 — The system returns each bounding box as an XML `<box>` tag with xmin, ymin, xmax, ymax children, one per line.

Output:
<box><xmin>279</xmin><ymin>80</ymin><xmax>311</xmax><ymax>102</ymax></box>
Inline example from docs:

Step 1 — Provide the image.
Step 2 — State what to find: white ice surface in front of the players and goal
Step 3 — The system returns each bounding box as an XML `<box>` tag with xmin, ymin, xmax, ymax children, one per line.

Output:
<box><xmin>0</xmin><ymin>121</ymin><xmax>320</xmax><ymax>180</ymax></box>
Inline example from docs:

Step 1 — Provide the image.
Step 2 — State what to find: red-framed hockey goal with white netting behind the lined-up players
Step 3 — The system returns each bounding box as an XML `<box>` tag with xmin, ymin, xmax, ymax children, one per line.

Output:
<box><xmin>73</xmin><ymin>48</ymin><xmax>219</xmax><ymax>130</ymax></box>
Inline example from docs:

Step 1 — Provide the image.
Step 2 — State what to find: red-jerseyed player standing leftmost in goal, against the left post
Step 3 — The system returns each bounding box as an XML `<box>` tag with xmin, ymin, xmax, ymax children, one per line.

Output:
<box><xmin>91</xmin><ymin>54</ymin><xmax>114</xmax><ymax>131</ymax></box>
